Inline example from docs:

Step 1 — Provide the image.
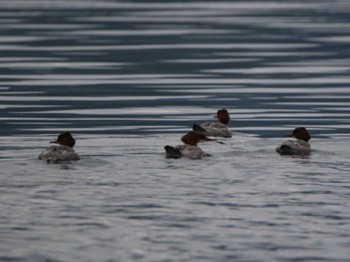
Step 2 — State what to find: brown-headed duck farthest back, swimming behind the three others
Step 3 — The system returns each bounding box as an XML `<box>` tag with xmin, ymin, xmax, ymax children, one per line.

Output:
<box><xmin>192</xmin><ymin>108</ymin><xmax>232</xmax><ymax>138</ymax></box>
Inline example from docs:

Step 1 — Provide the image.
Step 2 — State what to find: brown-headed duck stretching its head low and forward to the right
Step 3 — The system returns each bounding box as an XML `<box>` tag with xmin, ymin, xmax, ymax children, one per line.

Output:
<box><xmin>164</xmin><ymin>131</ymin><xmax>216</xmax><ymax>160</ymax></box>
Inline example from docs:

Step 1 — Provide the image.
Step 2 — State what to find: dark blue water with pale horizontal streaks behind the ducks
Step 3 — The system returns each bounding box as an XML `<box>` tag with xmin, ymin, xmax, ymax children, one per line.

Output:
<box><xmin>0</xmin><ymin>0</ymin><xmax>350</xmax><ymax>137</ymax></box>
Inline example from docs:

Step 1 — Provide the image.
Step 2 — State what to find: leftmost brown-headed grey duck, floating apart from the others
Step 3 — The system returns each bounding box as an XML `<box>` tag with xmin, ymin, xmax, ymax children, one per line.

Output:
<box><xmin>38</xmin><ymin>132</ymin><xmax>80</xmax><ymax>164</ymax></box>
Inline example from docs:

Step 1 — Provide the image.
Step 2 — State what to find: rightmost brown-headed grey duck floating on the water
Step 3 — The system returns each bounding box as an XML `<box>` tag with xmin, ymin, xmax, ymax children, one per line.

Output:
<box><xmin>276</xmin><ymin>127</ymin><xmax>311</xmax><ymax>155</ymax></box>
